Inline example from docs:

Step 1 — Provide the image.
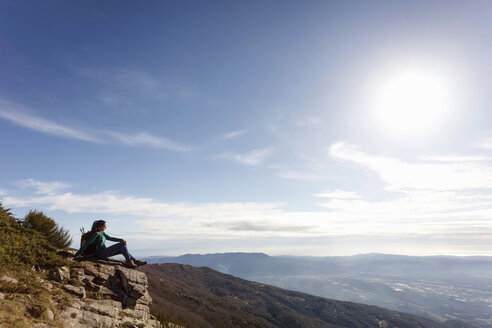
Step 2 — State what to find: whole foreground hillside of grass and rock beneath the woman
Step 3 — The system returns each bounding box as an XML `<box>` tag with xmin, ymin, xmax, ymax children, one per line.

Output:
<box><xmin>0</xmin><ymin>204</ymin><xmax>162</xmax><ymax>328</ymax></box>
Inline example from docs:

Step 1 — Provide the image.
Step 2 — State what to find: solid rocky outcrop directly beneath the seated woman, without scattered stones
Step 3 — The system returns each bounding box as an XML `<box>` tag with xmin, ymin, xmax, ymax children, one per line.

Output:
<box><xmin>50</xmin><ymin>260</ymin><xmax>161</xmax><ymax>328</ymax></box>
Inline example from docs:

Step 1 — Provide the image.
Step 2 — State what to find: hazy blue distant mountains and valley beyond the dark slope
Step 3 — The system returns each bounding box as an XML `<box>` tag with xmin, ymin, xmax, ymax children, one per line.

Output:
<box><xmin>143</xmin><ymin>253</ymin><xmax>492</xmax><ymax>328</ymax></box>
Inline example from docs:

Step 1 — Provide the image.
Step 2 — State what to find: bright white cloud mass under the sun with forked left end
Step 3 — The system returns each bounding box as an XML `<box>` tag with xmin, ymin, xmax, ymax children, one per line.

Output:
<box><xmin>315</xmin><ymin>142</ymin><xmax>492</xmax><ymax>235</ymax></box>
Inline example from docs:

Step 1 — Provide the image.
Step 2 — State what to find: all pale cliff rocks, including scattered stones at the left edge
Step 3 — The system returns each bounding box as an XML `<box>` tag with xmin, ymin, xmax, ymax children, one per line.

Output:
<box><xmin>0</xmin><ymin>259</ymin><xmax>162</xmax><ymax>328</ymax></box>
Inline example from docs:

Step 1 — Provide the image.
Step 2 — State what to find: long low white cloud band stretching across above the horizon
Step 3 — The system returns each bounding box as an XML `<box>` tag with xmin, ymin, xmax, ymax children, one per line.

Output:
<box><xmin>5</xmin><ymin>179</ymin><xmax>492</xmax><ymax>238</ymax></box>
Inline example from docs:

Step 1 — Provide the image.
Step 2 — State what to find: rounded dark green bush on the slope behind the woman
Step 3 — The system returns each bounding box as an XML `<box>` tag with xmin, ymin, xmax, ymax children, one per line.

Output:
<box><xmin>23</xmin><ymin>210</ymin><xmax>72</xmax><ymax>248</ymax></box>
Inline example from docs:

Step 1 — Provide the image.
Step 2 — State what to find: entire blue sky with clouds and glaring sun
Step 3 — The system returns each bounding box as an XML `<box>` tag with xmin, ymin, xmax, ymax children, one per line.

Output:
<box><xmin>0</xmin><ymin>0</ymin><xmax>492</xmax><ymax>256</ymax></box>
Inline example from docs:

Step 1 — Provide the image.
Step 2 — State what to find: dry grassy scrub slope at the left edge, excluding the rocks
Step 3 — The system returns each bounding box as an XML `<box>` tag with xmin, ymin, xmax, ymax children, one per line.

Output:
<box><xmin>0</xmin><ymin>204</ymin><xmax>73</xmax><ymax>328</ymax></box>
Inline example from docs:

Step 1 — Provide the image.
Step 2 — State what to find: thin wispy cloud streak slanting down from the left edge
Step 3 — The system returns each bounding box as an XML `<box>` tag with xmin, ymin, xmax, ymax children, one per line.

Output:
<box><xmin>0</xmin><ymin>99</ymin><xmax>190</xmax><ymax>152</ymax></box>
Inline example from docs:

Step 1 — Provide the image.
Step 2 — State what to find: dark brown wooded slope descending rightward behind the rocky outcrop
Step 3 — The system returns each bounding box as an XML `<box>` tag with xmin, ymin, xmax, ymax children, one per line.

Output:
<box><xmin>140</xmin><ymin>264</ymin><xmax>458</xmax><ymax>328</ymax></box>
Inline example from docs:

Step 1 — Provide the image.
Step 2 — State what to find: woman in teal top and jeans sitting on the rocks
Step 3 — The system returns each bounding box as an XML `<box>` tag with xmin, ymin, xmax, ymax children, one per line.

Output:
<box><xmin>73</xmin><ymin>220</ymin><xmax>147</xmax><ymax>268</ymax></box>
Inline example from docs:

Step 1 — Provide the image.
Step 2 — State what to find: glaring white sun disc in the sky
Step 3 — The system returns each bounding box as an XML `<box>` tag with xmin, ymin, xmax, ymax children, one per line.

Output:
<box><xmin>373</xmin><ymin>69</ymin><xmax>450</xmax><ymax>136</ymax></box>
